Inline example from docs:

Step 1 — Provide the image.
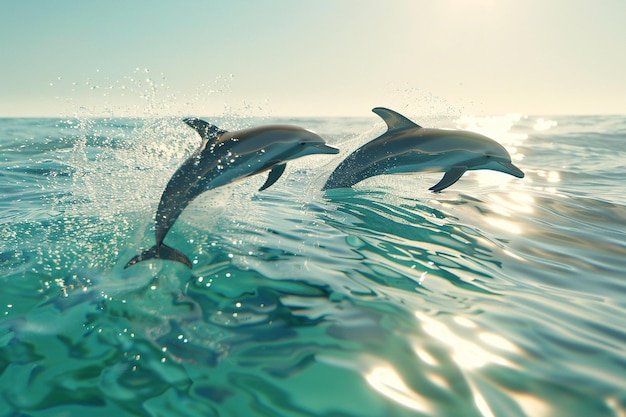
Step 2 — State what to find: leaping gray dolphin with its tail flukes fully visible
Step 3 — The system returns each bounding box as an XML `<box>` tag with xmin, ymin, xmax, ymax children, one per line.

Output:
<box><xmin>124</xmin><ymin>118</ymin><xmax>339</xmax><ymax>268</ymax></box>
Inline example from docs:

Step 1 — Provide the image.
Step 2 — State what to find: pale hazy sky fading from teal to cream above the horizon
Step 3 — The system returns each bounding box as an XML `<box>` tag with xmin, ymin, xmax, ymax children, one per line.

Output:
<box><xmin>0</xmin><ymin>0</ymin><xmax>626</xmax><ymax>117</ymax></box>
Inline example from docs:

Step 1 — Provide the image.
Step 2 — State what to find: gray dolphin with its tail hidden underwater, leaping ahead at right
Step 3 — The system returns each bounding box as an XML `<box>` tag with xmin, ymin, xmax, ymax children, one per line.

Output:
<box><xmin>322</xmin><ymin>107</ymin><xmax>524</xmax><ymax>192</ymax></box>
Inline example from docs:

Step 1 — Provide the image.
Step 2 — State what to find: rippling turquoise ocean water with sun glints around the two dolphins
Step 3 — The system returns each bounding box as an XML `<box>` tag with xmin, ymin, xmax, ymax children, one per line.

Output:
<box><xmin>0</xmin><ymin>115</ymin><xmax>626</xmax><ymax>417</ymax></box>
